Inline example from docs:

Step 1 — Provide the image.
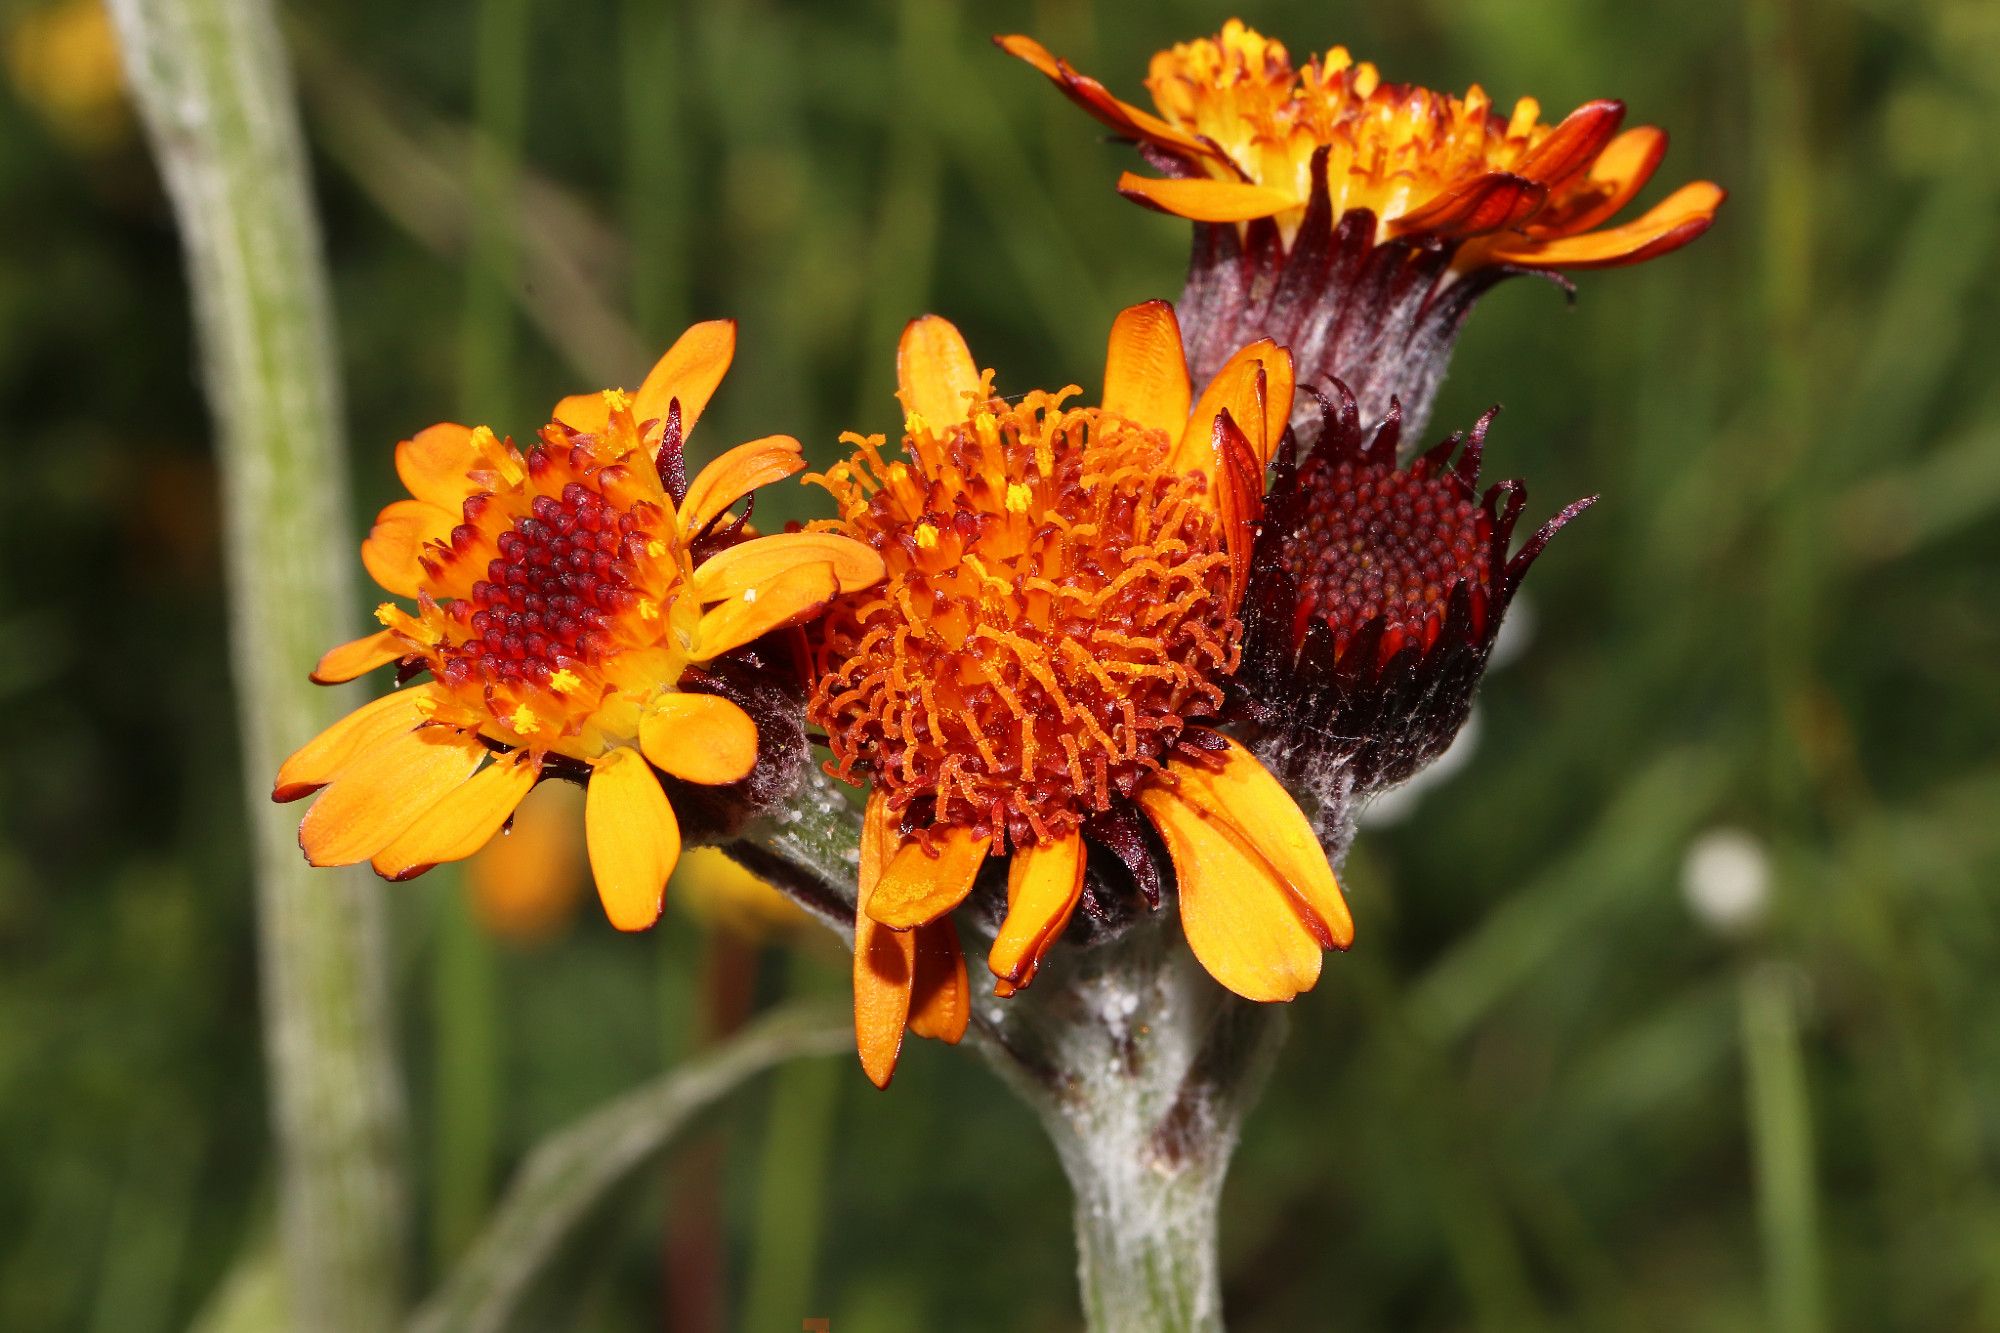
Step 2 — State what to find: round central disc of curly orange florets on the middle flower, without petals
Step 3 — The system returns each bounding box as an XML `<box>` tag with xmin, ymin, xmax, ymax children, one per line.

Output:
<box><xmin>812</xmin><ymin>374</ymin><xmax>1240</xmax><ymax>847</ymax></box>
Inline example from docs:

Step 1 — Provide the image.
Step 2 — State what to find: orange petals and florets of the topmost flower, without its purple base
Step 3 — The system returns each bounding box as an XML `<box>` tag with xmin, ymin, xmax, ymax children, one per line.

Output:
<box><xmin>998</xmin><ymin>20</ymin><xmax>1722</xmax><ymax>268</ymax></box>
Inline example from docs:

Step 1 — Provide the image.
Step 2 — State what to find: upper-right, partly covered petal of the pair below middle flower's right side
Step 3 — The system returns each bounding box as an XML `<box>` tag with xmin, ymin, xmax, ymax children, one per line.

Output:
<box><xmin>1168</xmin><ymin>729</ymin><xmax>1354</xmax><ymax>949</ymax></box>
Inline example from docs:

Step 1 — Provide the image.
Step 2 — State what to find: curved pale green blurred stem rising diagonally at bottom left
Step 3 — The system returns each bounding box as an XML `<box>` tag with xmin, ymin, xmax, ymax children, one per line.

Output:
<box><xmin>412</xmin><ymin>1005</ymin><xmax>852</xmax><ymax>1333</ymax></box>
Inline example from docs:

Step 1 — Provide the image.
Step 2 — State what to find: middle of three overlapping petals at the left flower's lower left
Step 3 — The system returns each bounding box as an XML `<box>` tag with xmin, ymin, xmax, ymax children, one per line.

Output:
<box><xmin>298</xmin><ymin>727</ymin><xmax>486</xmax><ymax>865</ymax></box>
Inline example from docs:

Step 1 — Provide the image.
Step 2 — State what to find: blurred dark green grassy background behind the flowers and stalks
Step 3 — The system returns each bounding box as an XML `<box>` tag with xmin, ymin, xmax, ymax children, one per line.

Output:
<box><xmin>0</xmin><ymin>0</ymin><xmax>2000</xmax><ymax>1333</ymax></box>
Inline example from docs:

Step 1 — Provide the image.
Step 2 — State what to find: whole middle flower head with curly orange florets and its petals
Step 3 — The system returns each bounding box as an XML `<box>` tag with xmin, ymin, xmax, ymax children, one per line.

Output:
<box><xmin>808</xmin><ymin>302</ymin><xmax>1350</xmax><ymax>1083</ymax></box>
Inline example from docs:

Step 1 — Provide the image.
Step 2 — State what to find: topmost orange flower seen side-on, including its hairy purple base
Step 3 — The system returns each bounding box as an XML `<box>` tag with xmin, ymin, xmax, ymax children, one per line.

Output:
<box><xmin>996</xmin><ymin>20</ymin><xmax>1722</xmax><ymax>444</ymax></box>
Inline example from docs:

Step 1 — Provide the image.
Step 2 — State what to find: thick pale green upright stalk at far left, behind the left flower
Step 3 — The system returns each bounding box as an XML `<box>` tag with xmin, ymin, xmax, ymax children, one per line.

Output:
<box><xmin>112</xmin><ymin>0</ymin><xmax>406</xmax><ymax>1333</ymax></box>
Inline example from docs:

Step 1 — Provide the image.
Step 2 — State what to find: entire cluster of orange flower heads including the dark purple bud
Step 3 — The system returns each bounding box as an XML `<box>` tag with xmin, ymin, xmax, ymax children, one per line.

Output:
<box><xmin>274</xmin><ymin>24</ymin><xmax>1720</xmax><ymax>1085</ymax></box>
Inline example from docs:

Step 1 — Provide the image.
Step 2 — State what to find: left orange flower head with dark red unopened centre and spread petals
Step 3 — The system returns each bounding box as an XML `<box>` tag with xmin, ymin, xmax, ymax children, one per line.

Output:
<box><xmin>272</xmin><ymin>320</ymin><xmax>882</xmax><ymax>929</ymax></box>
